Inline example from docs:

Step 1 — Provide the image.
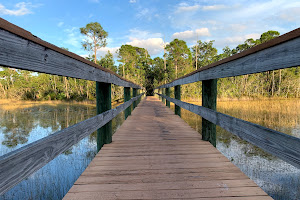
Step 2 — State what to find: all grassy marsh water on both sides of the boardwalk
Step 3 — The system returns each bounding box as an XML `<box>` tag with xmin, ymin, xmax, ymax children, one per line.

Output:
<box><xmin>0</xmin><ymin>99</ymin><xmax>300</xmax><ymax>200</ymax></box>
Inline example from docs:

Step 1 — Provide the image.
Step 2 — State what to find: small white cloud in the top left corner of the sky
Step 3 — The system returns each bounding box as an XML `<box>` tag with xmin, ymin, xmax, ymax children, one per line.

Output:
<box><xmin>0</xmin><ymin>2</ymin><xmax>35</xmax><ymax>16</ymax></box>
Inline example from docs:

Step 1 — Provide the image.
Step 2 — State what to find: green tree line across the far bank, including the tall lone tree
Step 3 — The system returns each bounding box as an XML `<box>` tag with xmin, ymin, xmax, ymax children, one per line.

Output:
<box><xmin>0</xmin><ymin>22</ymin><xmax>300</xmax><ymax>101</ymax></box>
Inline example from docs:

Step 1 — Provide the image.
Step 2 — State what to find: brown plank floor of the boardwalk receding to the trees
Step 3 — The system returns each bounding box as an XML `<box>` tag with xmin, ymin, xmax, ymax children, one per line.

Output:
<box><xmin>64</xmin><ymin>97</ymin><xmax>272</xmax><ymax>200</ymax></box>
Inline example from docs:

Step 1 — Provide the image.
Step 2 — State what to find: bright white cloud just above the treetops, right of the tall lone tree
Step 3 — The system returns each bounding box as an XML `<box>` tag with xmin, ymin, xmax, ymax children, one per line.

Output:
<box><xmin>126</xmin><ymin>38</ymin><xmax>164</xmax><ymax>56</ymax></box>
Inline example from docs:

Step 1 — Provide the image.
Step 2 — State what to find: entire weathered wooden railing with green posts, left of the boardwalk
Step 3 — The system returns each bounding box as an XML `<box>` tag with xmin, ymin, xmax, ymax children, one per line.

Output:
<box><xmin>0</xmin><ymin>18</ymin><xmax>143</xmax><ymax>195</ymax></box>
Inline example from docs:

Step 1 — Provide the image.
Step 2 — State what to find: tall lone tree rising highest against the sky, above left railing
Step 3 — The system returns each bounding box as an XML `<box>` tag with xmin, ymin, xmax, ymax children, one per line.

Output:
<box><xmin>80</xmin><ymin>22</ymin><xmax>108</xmax><ymax>63</ymax></box>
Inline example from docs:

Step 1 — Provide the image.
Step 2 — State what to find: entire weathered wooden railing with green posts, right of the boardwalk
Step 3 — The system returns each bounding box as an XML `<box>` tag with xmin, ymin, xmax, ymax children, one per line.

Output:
<box><xmin>156</xmin><ymin>28</ymin><xmax>300</xmax><ymax>168</ymax></box>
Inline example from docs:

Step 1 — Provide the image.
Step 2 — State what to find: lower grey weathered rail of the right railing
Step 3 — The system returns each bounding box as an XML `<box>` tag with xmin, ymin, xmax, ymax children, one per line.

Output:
<box><xmin>158</xmin><ymin>94</ymin><xmax>300</xmax><ymax>168</ymax></box>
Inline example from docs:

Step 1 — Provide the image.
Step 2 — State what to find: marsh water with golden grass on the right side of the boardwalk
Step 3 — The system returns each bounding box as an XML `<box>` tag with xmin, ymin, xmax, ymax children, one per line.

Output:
<box><xmin>171</xmin><ymin>99</ymin><xmax>300</xmax><ymax>200</ymax></box>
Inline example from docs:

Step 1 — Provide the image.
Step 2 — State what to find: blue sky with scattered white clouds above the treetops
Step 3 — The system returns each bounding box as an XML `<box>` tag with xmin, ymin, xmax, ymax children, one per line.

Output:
<box><xmin>0</xmin><ymin>0</ymin><xmax>300</xmax><ymax>57</ymax></box>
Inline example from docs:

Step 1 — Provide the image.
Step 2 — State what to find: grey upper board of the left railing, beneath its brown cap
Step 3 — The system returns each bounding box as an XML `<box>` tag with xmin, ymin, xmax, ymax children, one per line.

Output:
<box><xmin>0</xmin><ymin>27</ymin><xmax>141</xmax><ymax>88</ymax></box>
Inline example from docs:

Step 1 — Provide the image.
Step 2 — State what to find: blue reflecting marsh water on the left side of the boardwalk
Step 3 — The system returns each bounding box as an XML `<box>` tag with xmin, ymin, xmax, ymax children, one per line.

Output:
<box><xmin>0</xmin><ymin>103</ymin><xmax>124</xmax><ymax>200</ymax></box>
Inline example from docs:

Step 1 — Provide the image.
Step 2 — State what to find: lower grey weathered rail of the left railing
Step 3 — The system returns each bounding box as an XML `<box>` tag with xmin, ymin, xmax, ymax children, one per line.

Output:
<box><xmin>0</xmin><ymin>94</ymin><xmax>143</xmax><ymax>194</ymax></box>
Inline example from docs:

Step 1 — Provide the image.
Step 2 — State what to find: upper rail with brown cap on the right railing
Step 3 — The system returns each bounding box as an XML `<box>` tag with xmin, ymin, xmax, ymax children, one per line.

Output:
<box><xmin>156</xmin><ymin>28</ymin><xmax>300</xmax><ymax>89</ymax></box>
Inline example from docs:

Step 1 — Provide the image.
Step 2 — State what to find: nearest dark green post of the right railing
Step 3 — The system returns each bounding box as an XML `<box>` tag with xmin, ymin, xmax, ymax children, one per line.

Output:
<box><xmin>202</xmin><ymin>79</ymin><xmax>218</xmax><ymax>147</ymax></box>
